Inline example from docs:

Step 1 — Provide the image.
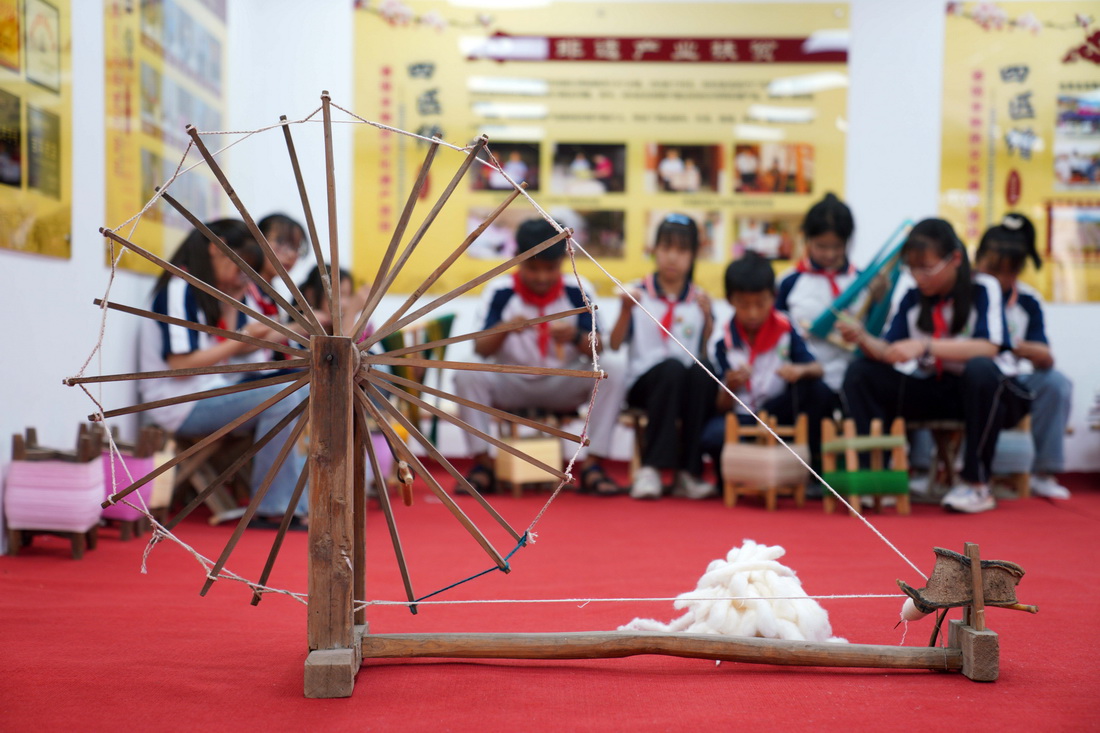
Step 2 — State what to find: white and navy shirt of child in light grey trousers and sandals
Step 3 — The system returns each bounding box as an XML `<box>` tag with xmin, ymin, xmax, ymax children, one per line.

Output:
<box><xmin>479</xmin><ymin>270</ymin><xmax>598</xmax><ymax>379</ymax></box>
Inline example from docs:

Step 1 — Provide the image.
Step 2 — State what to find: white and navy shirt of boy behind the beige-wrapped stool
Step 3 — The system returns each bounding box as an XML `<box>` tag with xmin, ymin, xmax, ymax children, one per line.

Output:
<box><xmin>707</xmin><ymin>310</ymin><xmax>815</xmax><ymax>415</ymax></box>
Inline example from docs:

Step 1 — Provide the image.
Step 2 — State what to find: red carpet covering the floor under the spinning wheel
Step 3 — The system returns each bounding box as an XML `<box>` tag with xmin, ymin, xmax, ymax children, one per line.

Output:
<box><xmin>0</xmin><ymin>464</ymin><xmax>1100</xmax><ymax>731</ymax></box>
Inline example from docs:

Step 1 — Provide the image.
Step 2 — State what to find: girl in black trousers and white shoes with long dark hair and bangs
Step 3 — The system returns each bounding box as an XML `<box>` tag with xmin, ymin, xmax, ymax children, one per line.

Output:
<box><xmin>611</xmin><ymin>214</ymin><xmax>716</xmax><ymax>499</ymax></box>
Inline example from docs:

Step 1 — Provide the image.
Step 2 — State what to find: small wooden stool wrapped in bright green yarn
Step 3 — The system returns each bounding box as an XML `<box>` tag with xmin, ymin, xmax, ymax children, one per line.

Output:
<box><xmin>822</xmin><ymin>417</ymin><xmax>910</xmax><ymax>514</ymax></box>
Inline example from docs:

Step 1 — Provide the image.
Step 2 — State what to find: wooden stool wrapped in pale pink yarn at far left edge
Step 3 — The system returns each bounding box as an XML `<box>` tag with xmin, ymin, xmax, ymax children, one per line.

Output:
<box><xmin>4</xmin><ymin>425</ymin><xmax>103</xmax><ymax>560</ymax></box>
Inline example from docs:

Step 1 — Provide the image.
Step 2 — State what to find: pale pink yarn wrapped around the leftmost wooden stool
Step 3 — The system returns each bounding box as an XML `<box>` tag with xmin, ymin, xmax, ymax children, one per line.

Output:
<box><xmin>3</xmin><ymin>458</ymin><xmax>103</xmax><ymax>532</ymax></box>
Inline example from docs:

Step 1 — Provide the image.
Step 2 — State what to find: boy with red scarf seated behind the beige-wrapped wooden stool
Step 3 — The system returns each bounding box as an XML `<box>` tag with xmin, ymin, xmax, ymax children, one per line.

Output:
<box><xmin>703</xmin><ymin>252</ymin><xmax>833</xmax><ymax>466</ymax></box>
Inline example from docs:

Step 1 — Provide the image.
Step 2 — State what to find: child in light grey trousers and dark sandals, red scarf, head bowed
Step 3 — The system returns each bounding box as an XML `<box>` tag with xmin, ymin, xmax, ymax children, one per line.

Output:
<box><xmin>454</xmin><ymin>219</ymin><xmax>619</xmax><ymax>494</ymax></box>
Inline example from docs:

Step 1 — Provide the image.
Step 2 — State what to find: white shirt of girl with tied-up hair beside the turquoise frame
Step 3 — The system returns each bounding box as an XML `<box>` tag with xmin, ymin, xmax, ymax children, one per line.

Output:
<box><xmin>776</xmin><ymin>262</ymin><xmax>868</xmax><ymax>392</ymax></box>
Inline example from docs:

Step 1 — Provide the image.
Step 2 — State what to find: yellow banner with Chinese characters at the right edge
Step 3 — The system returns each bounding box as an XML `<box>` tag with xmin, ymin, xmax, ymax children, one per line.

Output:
<box><xmin>941</xmin><ymin>2</ymin><xmax>1100</xmax><ymax>303</ymax></box>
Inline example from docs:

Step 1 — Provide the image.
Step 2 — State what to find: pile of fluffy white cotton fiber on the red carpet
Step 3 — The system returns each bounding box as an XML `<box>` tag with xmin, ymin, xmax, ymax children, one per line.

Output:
<box><xmin>619</xmin><ymin>539</ymin><xmax>847</xmax><ymax>643</ymax></box>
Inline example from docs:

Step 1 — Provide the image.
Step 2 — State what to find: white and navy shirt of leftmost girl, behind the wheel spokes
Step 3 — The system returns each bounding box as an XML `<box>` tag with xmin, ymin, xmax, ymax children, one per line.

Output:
<box><xmin>138</xmin><ymin>277</ymin><xmax>272</xmax><ymax>433</ymax></box>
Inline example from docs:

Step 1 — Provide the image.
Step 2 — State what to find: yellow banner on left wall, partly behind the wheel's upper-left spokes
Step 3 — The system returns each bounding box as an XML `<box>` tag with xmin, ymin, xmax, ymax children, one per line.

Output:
<box><xmin>105</xmin><ymin>0</ymin><xmax>226</xmax><ymax>274</ymax></box>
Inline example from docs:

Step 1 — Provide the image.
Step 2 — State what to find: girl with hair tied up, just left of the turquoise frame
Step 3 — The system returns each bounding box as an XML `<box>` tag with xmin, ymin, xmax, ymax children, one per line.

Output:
<box><xmin>776</xmin><ymin>194</ymin><xmax>867</xmax><ymax>412</ymax></box>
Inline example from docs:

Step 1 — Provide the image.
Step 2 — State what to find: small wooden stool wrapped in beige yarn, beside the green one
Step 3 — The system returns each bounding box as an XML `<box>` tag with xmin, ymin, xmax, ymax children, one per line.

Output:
<box><xmin>722</xmin><ymin>413</ymin><xmax>810</xmax><ymax>512</ymax></box>
